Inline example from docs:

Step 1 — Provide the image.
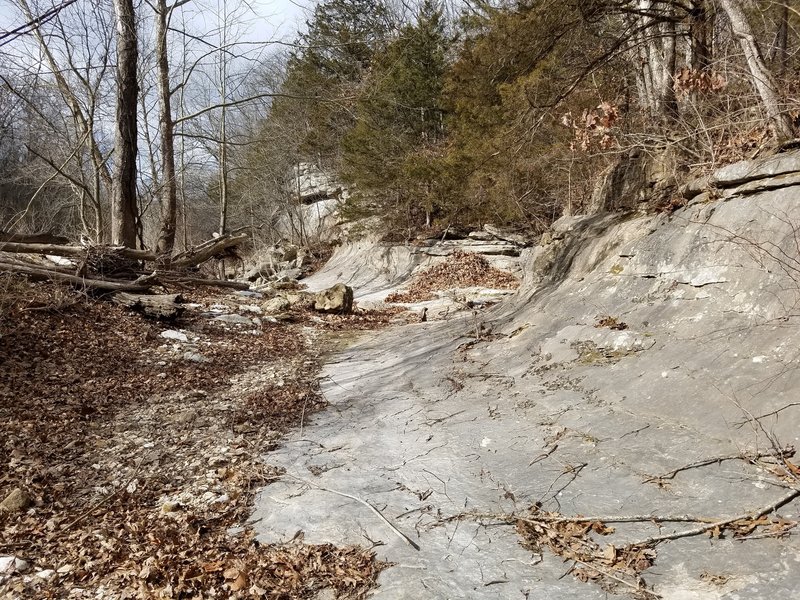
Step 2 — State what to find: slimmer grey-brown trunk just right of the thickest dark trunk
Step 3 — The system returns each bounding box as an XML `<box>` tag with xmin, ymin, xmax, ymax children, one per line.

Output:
<box><xmin>156</xmin><ymin>0</ymin><xmax>178</xmax><ymax>256</ymax></box>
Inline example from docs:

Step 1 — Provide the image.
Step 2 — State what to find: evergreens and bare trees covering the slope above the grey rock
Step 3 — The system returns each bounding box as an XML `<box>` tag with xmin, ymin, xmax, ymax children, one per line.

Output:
<box><xmin>237</xmin><ymin>0</ymin><xmax>800</xmax><ymax>237</ymax></box>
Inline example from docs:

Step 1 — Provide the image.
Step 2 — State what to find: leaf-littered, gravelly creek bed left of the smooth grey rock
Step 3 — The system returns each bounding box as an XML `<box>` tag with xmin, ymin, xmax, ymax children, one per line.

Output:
<box><xmin>0</xmin><ymin>277</ymin><xmax>404</xmax><ymax>598</ymax></box>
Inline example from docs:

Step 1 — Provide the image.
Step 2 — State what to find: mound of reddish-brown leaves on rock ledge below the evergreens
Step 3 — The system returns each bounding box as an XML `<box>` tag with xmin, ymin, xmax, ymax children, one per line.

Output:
<box><xmin>386</xmin><ymin>252</ymin><xmax>519</xmax><ymax>303</ymax></box>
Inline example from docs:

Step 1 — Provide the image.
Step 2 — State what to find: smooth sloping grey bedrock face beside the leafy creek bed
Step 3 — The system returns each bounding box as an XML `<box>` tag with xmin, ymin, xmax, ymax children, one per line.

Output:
<box><xmin>257</xmin><ymin>155</ymin><xmax>800</xmax><ymax>599</ymax></box>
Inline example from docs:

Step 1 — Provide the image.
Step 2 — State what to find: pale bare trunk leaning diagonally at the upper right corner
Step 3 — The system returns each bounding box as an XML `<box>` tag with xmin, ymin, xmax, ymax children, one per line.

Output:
<box><xmin>719</xmin><ymin>0</ymin><xmax>792</xmax><ymax>142</ymax></box>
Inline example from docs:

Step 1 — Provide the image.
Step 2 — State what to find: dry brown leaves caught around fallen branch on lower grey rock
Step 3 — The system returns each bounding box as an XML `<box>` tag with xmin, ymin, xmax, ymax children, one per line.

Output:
<box><xmin>517</xmin><ymin>507</ymin><xmax>656</xmax><ymax>594</ymax></box>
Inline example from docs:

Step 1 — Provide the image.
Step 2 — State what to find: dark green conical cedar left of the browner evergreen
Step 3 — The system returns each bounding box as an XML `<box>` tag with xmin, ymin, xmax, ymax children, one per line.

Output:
<box><xmin>343</xmin><ymin>0</ymin><xmax>449</xmax><ymax>227</ymax></box>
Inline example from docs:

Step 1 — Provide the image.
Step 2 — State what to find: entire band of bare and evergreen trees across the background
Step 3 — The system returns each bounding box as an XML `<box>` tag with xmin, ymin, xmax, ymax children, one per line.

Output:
<box><xmin>0</xmin><ymin>0</ymin><xmax>800</xmax><ymax>248</ymax></box>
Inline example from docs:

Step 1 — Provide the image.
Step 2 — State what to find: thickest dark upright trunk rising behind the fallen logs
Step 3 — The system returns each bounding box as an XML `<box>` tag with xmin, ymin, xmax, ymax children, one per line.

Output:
<box><xmin>111</xmin><ymin>0</ymin><xmax>139</xmax><ymax>248</ymax></box>
